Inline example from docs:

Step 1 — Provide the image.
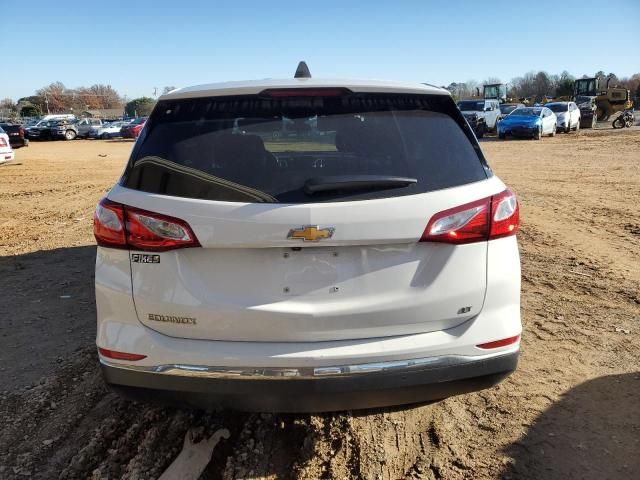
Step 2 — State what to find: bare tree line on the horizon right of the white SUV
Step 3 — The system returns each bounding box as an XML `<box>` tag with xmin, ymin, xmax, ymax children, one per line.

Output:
<box><xmin>444</xmin><ymin>70</ymin><xmax>640</xmax><ymax>101</ymax></box>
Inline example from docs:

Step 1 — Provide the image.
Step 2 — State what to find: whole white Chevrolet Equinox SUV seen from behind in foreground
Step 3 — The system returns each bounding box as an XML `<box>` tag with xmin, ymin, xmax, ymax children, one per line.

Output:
<box><xmin>94</xmin><ymin>67</ymin><xmax>521</xmax><ymax>412</ymax></box>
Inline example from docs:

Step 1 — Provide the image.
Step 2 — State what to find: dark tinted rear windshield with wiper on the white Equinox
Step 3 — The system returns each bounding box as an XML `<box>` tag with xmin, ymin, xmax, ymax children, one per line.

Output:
<box><xmin>121</xmin><ymin>94</ymin><xmax>490</xmax><ymax>203</ymax></box>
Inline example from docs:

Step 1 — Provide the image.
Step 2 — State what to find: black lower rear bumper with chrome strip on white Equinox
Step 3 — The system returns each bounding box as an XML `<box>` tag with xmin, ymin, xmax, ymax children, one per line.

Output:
<box><xmin>101</xmin><ymin>346</ymin><xmax>519</xmax><ymax>412</ymax></box>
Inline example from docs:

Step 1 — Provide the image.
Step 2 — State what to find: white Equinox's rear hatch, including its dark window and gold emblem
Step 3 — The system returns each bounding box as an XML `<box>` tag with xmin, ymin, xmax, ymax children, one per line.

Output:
<box><xmin>109</xmin><ymin>88</ymin><xmax>496</xmax><ymax>342</ymax></box>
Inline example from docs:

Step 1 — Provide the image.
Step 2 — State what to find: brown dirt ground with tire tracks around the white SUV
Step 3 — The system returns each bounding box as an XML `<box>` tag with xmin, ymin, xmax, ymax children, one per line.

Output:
<box><xmin>0</xmin><ymin>128</ymin><xmax>640</xmax><ymax>480</ymax></box>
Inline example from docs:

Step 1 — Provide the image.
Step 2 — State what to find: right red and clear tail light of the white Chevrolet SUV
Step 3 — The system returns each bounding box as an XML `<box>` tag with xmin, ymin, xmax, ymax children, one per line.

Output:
<box><xmin>420</xmin><ymin>189</ymin><xmax>520</xmax><ymax>244</ymax></box>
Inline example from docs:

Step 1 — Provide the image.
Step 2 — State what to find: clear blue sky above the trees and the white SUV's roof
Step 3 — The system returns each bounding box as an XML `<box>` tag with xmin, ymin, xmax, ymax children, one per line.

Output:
<box><xmin>0</xmin><ymin>0</ymin><xmax>640</xmax><ymax>100</ymax></box>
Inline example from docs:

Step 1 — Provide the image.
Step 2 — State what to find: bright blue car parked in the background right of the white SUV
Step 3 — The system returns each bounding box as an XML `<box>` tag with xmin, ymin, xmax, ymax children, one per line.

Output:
<box><xmin>498</xmin><ymin>107</ymin><xmax>557</xmax><ymax>140</ymax></box>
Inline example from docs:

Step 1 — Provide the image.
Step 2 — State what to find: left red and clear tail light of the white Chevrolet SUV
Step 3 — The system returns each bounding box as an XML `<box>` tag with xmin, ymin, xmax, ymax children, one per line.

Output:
<box><xmin>93</xmin><ymin>198</ymin><xmax>200</xmax><ymax>252</ymax></box>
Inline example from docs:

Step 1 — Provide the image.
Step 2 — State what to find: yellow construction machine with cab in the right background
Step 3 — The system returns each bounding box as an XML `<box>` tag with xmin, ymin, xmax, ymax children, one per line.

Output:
<box><xmin>573</xmin><ymin>77</ymin><xmax>633</xmax><ymax>121</ymax></box>
